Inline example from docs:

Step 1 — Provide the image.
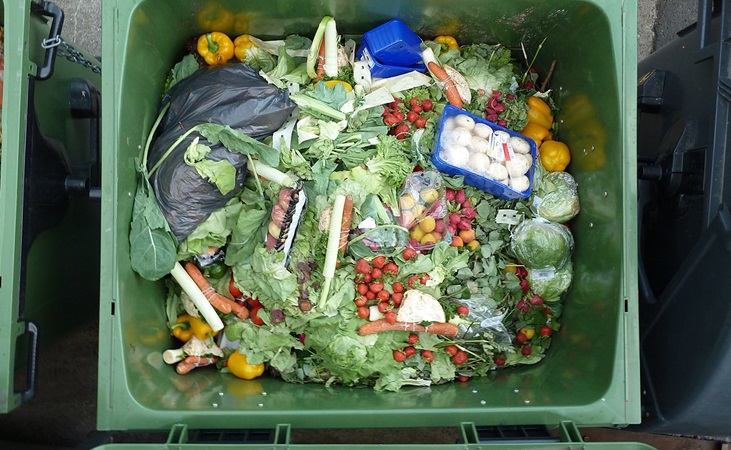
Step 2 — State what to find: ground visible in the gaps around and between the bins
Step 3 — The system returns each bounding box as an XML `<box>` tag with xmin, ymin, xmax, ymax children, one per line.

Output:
<box><xmin>0</xmin><ymin>0</ymin><xmax>722</xmax><ymax>450</ymax></box>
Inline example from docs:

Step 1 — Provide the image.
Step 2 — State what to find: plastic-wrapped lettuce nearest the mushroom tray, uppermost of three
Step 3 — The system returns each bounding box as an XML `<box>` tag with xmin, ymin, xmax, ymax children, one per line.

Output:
<box><xmin>533</xmin><ymin>172</ymin><xmax>580</xmax><ymax>223</ymax></box>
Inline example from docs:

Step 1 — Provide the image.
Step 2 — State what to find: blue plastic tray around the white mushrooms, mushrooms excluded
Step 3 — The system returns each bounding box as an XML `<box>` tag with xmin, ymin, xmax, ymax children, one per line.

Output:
<box><xmin>431</xmin><ymin>105</ymin><xmax>538</xmax><ymax>200</ymax></box>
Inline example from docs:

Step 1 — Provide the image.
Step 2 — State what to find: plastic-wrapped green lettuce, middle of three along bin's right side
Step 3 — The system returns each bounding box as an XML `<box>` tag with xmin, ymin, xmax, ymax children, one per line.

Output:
<box><xmin>510</xmin><ymin>217</ymin><xmax>574</xmax><ymax>269</ymax></box>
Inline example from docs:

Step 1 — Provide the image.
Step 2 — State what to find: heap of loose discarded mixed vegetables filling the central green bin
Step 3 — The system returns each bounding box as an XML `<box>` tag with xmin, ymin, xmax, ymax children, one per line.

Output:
<box><xmin>130</xmin><ymin>17</ymin><xmax>573</xmax><ymax>391</ymax></box>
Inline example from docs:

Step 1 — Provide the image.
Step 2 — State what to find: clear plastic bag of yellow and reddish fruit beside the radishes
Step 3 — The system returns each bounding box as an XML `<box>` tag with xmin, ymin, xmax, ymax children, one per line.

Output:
<box><xmin>399</xmin><ymin>171</ymin><xmax>452</xmax><ymax>251</ymax></box>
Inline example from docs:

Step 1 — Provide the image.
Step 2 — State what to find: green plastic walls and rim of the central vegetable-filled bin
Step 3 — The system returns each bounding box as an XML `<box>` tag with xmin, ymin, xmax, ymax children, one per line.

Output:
<box><xmin>97</xmin><ymin>0</ymin><xmax>640</xmax><ymax>436</ymax></box>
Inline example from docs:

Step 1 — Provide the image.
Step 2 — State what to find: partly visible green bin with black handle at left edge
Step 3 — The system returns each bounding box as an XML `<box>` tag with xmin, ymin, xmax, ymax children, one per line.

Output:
<box><xmin>0</xmin><ymin>0</ymin><xmax>101</xmax><ymax>413</ymax></box>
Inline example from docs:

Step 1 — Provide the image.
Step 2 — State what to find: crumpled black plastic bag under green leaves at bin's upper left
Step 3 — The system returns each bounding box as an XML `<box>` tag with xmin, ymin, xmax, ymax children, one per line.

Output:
<box><xmin>148</xmin><ymin>64</ymin><xmax>295</xmax><ymax>242</ymax></box>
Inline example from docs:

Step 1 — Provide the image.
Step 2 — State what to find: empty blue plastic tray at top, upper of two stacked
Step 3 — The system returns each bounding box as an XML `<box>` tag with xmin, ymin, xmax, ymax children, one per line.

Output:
<box><xmin>363</xmin><ymin>19</ymin><xmax>421</xmax><ymax>66</ymax></box>
